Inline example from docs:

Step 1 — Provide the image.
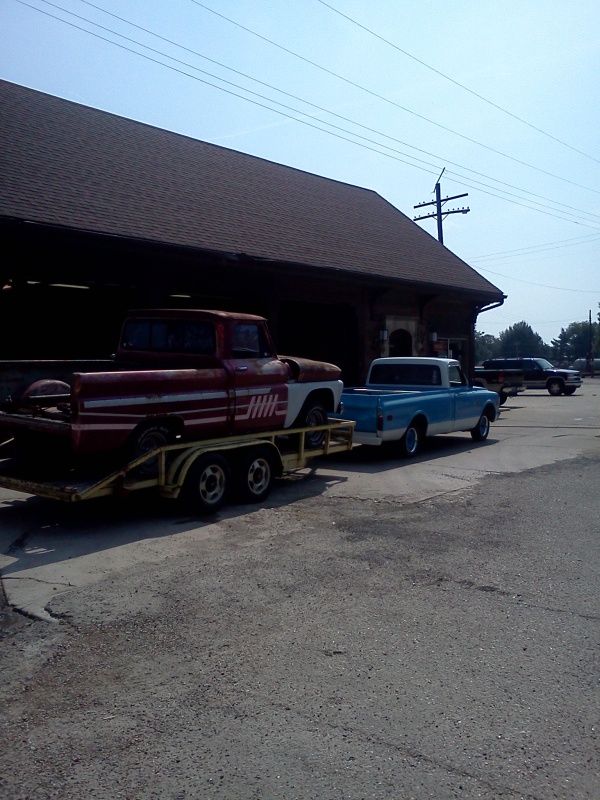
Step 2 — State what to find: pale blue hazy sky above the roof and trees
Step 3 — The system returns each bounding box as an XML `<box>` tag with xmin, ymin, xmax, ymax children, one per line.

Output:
<box><xmin>0</xmin><ymin>0</ymin><xmax>600</xmax><ymax>342</ymax></box>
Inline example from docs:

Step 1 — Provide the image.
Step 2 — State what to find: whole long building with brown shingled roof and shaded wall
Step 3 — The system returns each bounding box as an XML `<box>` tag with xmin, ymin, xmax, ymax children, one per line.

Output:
<box><xmin>0</xmin><ymin>81</ymin><xmax>504</xmax><ymax>385</ymax></box>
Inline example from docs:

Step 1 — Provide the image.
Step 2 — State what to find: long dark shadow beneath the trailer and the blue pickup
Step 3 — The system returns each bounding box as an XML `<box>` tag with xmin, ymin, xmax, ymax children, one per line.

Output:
<box><xmin>0</xmin><ymin>435</ymin><xmax>494</xmax><ymax>575</ymax></box>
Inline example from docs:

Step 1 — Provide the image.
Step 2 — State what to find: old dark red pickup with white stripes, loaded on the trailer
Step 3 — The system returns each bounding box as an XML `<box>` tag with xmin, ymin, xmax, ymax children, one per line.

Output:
<box><xmin>0</xmin><ymin>309</ymin><xmax>343</xmax><ymax>458</ymax></box>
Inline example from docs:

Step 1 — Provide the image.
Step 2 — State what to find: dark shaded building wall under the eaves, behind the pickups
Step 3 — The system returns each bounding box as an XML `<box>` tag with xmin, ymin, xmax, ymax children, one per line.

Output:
<box><xmin>0</xmin><ymin>225</ymin><xmax>488</xmax><ymax>385</ymax></box>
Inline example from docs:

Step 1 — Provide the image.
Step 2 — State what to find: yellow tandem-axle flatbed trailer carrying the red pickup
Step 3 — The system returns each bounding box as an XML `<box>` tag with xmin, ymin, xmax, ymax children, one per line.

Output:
<box><xmin>0</xmin><ymin>420</ymin><xmax>355</xmax><ymax>513</ymax></box>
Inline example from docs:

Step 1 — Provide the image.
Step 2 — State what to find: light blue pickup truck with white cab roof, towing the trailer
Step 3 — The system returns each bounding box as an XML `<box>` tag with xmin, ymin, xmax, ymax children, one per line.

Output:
<box><xmin>336</xmin><ymin>357</ymin><xmax>500</xmax><ymax>457</ymax></box>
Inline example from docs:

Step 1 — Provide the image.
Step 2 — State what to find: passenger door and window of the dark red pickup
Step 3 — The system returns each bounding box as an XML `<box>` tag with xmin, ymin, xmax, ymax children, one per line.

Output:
<box><xmin>226</xmin><ymin>321</ymin><xmax>289</xmax><ymax>433</ymax></box>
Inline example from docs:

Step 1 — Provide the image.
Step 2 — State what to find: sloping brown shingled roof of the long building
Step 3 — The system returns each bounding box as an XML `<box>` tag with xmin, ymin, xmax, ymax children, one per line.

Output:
<box><xmin>0</xmin><ymin>81</ymin><xmax>502</xmax><ymax>300</ymax></box>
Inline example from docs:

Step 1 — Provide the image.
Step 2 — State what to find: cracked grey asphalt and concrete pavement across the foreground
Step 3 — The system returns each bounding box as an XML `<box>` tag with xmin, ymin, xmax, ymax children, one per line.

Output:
<box><xmin>0</xmin><ymin>383</ymin><xmax>600</xmax><ymax>800</ymax></box>
